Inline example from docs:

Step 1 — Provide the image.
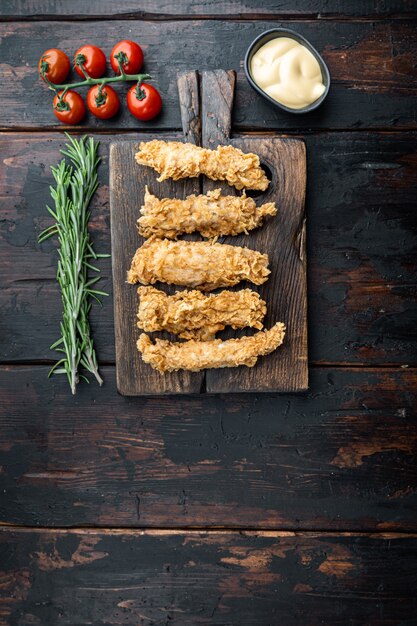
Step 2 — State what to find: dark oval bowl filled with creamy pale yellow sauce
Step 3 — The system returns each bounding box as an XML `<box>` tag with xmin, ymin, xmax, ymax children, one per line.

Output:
<box><xmin>245</xmin><ymin>29</ymin><xmax>330</xmax><ymax>113</ymax></box>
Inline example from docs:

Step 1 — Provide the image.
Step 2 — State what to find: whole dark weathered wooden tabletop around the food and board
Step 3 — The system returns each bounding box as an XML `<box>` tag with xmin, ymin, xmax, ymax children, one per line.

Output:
<box><xmin>0</xmin><ymin>0</ymin><xmax>417</xmax><ymax>626</ymax></box>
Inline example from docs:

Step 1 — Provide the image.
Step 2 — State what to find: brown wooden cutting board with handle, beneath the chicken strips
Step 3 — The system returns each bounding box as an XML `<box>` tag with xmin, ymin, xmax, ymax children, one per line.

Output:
<box><xmin>110</xmin><ymin>70</ymin><xmax>308</xmax><ymax>396</ymax></box>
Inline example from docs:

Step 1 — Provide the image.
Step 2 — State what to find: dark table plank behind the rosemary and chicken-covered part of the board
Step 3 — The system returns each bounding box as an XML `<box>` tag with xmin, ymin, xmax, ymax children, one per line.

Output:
<box><xmin>0</xmin><ymin>133</ymin><xmax>417</xmax><ymax>364</ymax></box>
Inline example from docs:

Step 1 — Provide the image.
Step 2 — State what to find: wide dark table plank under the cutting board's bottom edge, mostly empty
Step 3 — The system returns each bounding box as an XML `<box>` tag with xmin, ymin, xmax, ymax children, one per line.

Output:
<box><xmin>0</xmin><ymin>366</ymin><xmax>417</xmax><ymax>528</ymax></box>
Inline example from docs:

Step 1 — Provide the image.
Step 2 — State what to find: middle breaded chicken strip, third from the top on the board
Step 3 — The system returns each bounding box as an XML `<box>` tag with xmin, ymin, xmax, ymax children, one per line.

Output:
<box><xmin>127</xmin><ymin>239</ymin><xmax>270</xmax><ymax>291</ymax></box>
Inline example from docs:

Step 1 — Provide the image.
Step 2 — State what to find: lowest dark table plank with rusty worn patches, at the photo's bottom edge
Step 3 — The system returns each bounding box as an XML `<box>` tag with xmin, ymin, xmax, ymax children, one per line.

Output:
<box><xmin>0</xmin><ymin>529</ymin><xmax>417</xmax><ymax>626</ymax></box>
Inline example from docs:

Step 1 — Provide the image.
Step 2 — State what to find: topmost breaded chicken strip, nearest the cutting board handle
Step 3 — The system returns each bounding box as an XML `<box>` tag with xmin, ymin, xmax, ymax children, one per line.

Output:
<box><xmin>135</xmin><ymin>139</ymin><xmax>269</xmax><ymax>191</ymax></box>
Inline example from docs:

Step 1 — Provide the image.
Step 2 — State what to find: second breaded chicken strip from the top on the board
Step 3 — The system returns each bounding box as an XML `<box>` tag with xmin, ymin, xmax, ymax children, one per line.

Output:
<box><xmin>138</xmin><ymin>187</ymin><xmax>277</xmax><ymax>239</ymax></box>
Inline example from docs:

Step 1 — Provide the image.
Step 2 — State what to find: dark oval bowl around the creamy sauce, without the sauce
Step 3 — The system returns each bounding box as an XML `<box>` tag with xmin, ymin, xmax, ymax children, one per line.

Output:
<box><xmin>244</xmin><ymin>28</ymin><xmax>330</xmax><ymax>113</ymax></box>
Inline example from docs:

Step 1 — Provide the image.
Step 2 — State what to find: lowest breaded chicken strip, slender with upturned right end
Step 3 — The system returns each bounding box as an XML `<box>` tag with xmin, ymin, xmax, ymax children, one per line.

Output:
<box><xmin>137</xmin><ymin>322</ymin><xmax>285</xmax><ymax>374</ymax></box>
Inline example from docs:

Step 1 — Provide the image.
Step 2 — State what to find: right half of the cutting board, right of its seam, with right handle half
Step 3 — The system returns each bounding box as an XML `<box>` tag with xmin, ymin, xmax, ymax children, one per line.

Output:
<box><xmin>197</xmin><ymin>70</ymin><xmax>308</xmax><ymax>393</ymax></box>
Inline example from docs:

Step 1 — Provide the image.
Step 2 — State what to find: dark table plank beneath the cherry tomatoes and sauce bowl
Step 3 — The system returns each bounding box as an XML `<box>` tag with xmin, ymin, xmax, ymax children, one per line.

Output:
<box><xmin>0</xmin><ymin>19</ymin><xmax>417</xmax><ymax>131</ymax></box>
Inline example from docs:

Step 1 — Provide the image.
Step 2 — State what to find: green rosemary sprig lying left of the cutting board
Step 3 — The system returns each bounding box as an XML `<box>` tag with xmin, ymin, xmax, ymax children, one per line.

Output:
<box><xmin>38</xmin><ymin>134</ymin><xmax>109</xmax><ymax>394</ymax></box>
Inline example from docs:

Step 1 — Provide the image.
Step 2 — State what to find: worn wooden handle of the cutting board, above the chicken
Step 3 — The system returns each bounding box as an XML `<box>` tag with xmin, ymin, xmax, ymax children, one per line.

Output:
<box><xmin>177</xmin><ymin>70</ymin><xmax>236</xmax><ymax>148</ymax></box>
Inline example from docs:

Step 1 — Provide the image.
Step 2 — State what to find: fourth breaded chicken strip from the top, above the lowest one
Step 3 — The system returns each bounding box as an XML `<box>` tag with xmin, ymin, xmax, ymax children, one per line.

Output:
<box><xmin>138</xmin><ymin>287</ymin><xmax>266</xmax><ymax>341</ymax></box>
